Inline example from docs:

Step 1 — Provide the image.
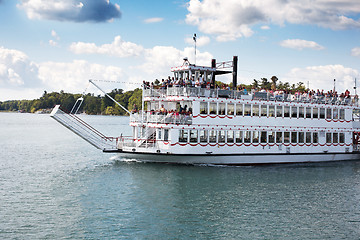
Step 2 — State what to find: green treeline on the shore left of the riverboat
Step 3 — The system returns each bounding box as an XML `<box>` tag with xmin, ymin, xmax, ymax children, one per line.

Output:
<box><xmin>0</xmin><ymin>88</ymin><xmax>142</xmax><ymax>115</ymax></box>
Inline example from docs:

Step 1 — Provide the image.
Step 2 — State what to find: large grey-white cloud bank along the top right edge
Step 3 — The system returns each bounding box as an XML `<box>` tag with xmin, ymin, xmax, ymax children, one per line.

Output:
<box><xmin>186</xmin><ymin>0</ymin><xmax>360</xmax><ymax>41</ymax></box>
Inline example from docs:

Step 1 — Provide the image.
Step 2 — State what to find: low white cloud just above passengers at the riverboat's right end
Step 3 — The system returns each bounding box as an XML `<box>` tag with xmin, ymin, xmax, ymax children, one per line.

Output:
<box><xmin>284</xmin><ymin>65</ymin><xmax>359</xmax><ymax>92</ymax></box>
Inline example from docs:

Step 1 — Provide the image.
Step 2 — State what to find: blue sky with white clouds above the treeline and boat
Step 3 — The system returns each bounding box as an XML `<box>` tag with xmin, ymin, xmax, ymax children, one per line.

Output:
<box><xmin>0</xmin><ymin>0</ymin><xmax>360</xmax><ymax>101</ymax></box>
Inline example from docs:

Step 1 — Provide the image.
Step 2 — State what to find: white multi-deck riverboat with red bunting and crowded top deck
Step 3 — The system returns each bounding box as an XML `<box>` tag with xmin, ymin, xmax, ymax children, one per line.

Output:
<box><xmin>51</xmin><ymin>56</ymin><xmax>360</xmax><ymax>165</ymax></box>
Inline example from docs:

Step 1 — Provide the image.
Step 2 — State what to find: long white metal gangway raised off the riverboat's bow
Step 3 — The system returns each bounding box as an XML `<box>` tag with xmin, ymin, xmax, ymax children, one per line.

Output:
<box><xmin>50</xmin><ymin>105</ymin><xmax>118</xmax><ymax>151</ymax></box>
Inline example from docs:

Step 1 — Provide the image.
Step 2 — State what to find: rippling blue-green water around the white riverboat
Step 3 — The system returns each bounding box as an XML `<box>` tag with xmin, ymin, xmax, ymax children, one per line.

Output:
<box><xmin>0</xmin><ymin>113</ymin><xmax>360</xmax><ymax>239</ymax></box>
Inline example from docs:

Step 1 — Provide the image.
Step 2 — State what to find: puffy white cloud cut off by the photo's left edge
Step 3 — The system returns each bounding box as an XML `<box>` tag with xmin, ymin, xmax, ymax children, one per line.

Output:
<box><xmin>0</xmin><ymin>47</ymin><xmax>40</xmax><ymax>88</ymax></box>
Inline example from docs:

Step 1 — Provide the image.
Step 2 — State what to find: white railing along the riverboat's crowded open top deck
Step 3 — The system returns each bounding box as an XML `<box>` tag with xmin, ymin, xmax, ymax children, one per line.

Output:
<box><xmin>144</xmin><ymin>87</ymin><xmax>359</xmax><ymax>106</ymax></box>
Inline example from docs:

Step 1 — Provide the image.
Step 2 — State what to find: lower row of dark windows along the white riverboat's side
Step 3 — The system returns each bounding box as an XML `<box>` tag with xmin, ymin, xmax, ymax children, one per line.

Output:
<box><xmin>179</xmin><ymin>129</ymin><xmax>345</xmax><ymax>143</ymax></box>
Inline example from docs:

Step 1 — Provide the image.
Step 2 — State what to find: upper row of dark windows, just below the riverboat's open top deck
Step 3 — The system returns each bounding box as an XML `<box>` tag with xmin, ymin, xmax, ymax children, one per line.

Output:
<box><xmin>200</xmin><ymin>102</ymin><xmax>345</xmax><ymax>120</ymax></box>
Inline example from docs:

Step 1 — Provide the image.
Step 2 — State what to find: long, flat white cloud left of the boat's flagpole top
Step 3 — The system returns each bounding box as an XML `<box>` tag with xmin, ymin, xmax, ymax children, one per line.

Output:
<box><xmin>70</xmin><ymin>36</ymin><xmax>144</xmax><ymax>57</ymax></box>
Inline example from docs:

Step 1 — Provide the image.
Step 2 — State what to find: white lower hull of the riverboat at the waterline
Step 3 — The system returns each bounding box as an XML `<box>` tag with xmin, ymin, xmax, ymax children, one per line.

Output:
<box><xmin>119</xmin><ymin>152</ymin><xmax>360</xmax><ymax>165</ymax></box>
